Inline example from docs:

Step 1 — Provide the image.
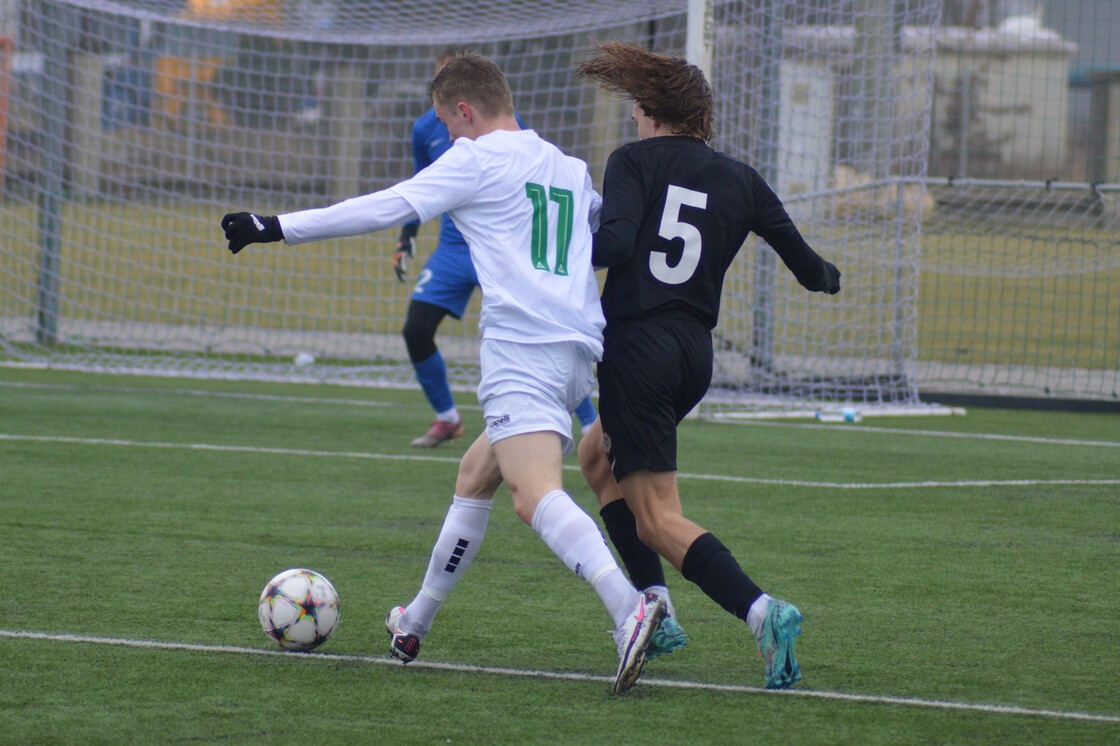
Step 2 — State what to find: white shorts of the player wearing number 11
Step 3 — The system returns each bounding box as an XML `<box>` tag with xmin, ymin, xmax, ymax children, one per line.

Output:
<box><xmin>478</xmin><ymin>339</ymin><xmax>595</xmax><ymax>456</ymax></box>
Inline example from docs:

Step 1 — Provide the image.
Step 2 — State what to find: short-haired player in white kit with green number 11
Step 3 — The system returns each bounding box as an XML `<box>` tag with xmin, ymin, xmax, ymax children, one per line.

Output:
<box><xmin>222</xmin><ymin>54</ymin><xmax>665</xmax><ymax>692</ymax></box>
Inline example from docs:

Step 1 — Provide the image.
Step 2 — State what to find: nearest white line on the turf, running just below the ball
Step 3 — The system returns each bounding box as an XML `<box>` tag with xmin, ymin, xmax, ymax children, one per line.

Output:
<box><xmin>0</xmin><ymin>630</ymin><xmax>1120</xmax><ymax>724</ymax></box>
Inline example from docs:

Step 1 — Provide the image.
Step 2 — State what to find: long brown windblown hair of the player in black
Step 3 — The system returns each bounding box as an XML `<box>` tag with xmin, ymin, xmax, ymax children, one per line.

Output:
<box><xmin>576</xmin><ymin>41</ymin><xmax>712</xmax><ymax>142</ymax></box>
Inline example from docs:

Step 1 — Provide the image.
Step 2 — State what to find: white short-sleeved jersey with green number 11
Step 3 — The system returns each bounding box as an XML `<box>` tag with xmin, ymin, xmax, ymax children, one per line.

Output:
<box><xmin>389</xmin><ymin>130</ymin><xmax>606</xmax><ymax>358</ymax></box>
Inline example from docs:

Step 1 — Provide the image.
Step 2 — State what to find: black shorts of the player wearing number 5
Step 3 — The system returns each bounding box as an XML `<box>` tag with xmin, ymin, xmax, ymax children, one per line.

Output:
<box><xmin>599</xmin><ymin>318</ymin><xmax>712</xmax><ymax>479</ymax></box>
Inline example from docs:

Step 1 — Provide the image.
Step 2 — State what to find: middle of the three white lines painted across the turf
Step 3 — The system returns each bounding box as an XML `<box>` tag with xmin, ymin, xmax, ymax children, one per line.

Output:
<box><xmin>0</xmin><ymin>432</ymin><xmax>1120</xmax><ymax>489</ymax></box>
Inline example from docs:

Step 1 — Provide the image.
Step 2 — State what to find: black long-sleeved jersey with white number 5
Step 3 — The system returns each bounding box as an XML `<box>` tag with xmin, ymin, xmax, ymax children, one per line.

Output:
<box><xmin>592</xmin><ymin>136</ymin><xmax>839</xmax><ymax>328</ymax></box>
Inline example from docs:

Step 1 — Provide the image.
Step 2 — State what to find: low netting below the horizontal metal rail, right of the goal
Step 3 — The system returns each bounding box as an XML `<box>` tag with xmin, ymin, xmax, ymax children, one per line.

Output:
<box><xmin>917</xmin><ymin>179</ymin><xmax>1120</xmax><ymax>402</ymax></box>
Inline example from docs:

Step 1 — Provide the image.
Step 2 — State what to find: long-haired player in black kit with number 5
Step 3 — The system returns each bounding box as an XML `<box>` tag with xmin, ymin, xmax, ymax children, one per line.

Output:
<box><xmin>577</xmin><ymin>41</ymin><xmax>840</xmax><ymax>689</ymax></box>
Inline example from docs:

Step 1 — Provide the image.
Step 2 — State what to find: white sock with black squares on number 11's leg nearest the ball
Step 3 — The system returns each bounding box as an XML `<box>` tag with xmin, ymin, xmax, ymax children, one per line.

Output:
<box><xmin>400</xmin><ymin>495</ymin><xmax>491</xmax><ymax>637</ymax></box>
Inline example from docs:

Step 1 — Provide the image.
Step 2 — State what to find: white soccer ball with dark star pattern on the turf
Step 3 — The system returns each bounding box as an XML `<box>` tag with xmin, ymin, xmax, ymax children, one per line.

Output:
<box><xmin>256</xmin><ymin>568</ymin><xmax>338</xmax><ymax>652</ymax></box>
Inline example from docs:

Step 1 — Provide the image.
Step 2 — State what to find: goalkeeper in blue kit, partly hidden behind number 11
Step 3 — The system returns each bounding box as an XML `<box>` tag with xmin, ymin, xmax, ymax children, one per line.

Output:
<box><xmin>393</xmin><ymin>45</ymin><xmax>597</xmax><ymax>448</ymax></box>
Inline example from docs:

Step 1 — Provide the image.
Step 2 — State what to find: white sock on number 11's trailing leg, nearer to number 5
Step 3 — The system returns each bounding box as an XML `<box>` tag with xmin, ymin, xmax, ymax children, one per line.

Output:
<box><xmin>533</xmin><ymin>489</ymin><xmax>642</xmax><ymax>627</ymax></box>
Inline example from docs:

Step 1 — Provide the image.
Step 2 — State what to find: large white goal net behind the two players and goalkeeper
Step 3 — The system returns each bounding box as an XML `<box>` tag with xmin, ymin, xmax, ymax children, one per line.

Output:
<box><xmin>0</xmin><ymin>0</ymin><xmax>941</xmax><ymax>416</ymax></box>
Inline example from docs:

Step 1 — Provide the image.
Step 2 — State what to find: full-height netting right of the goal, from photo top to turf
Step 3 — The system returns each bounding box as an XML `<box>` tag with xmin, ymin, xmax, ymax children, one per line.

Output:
<box><xmin>917</xmin><ymin>0</ymin><xmax>1120</xmax><ymax>408</ymax></box>
